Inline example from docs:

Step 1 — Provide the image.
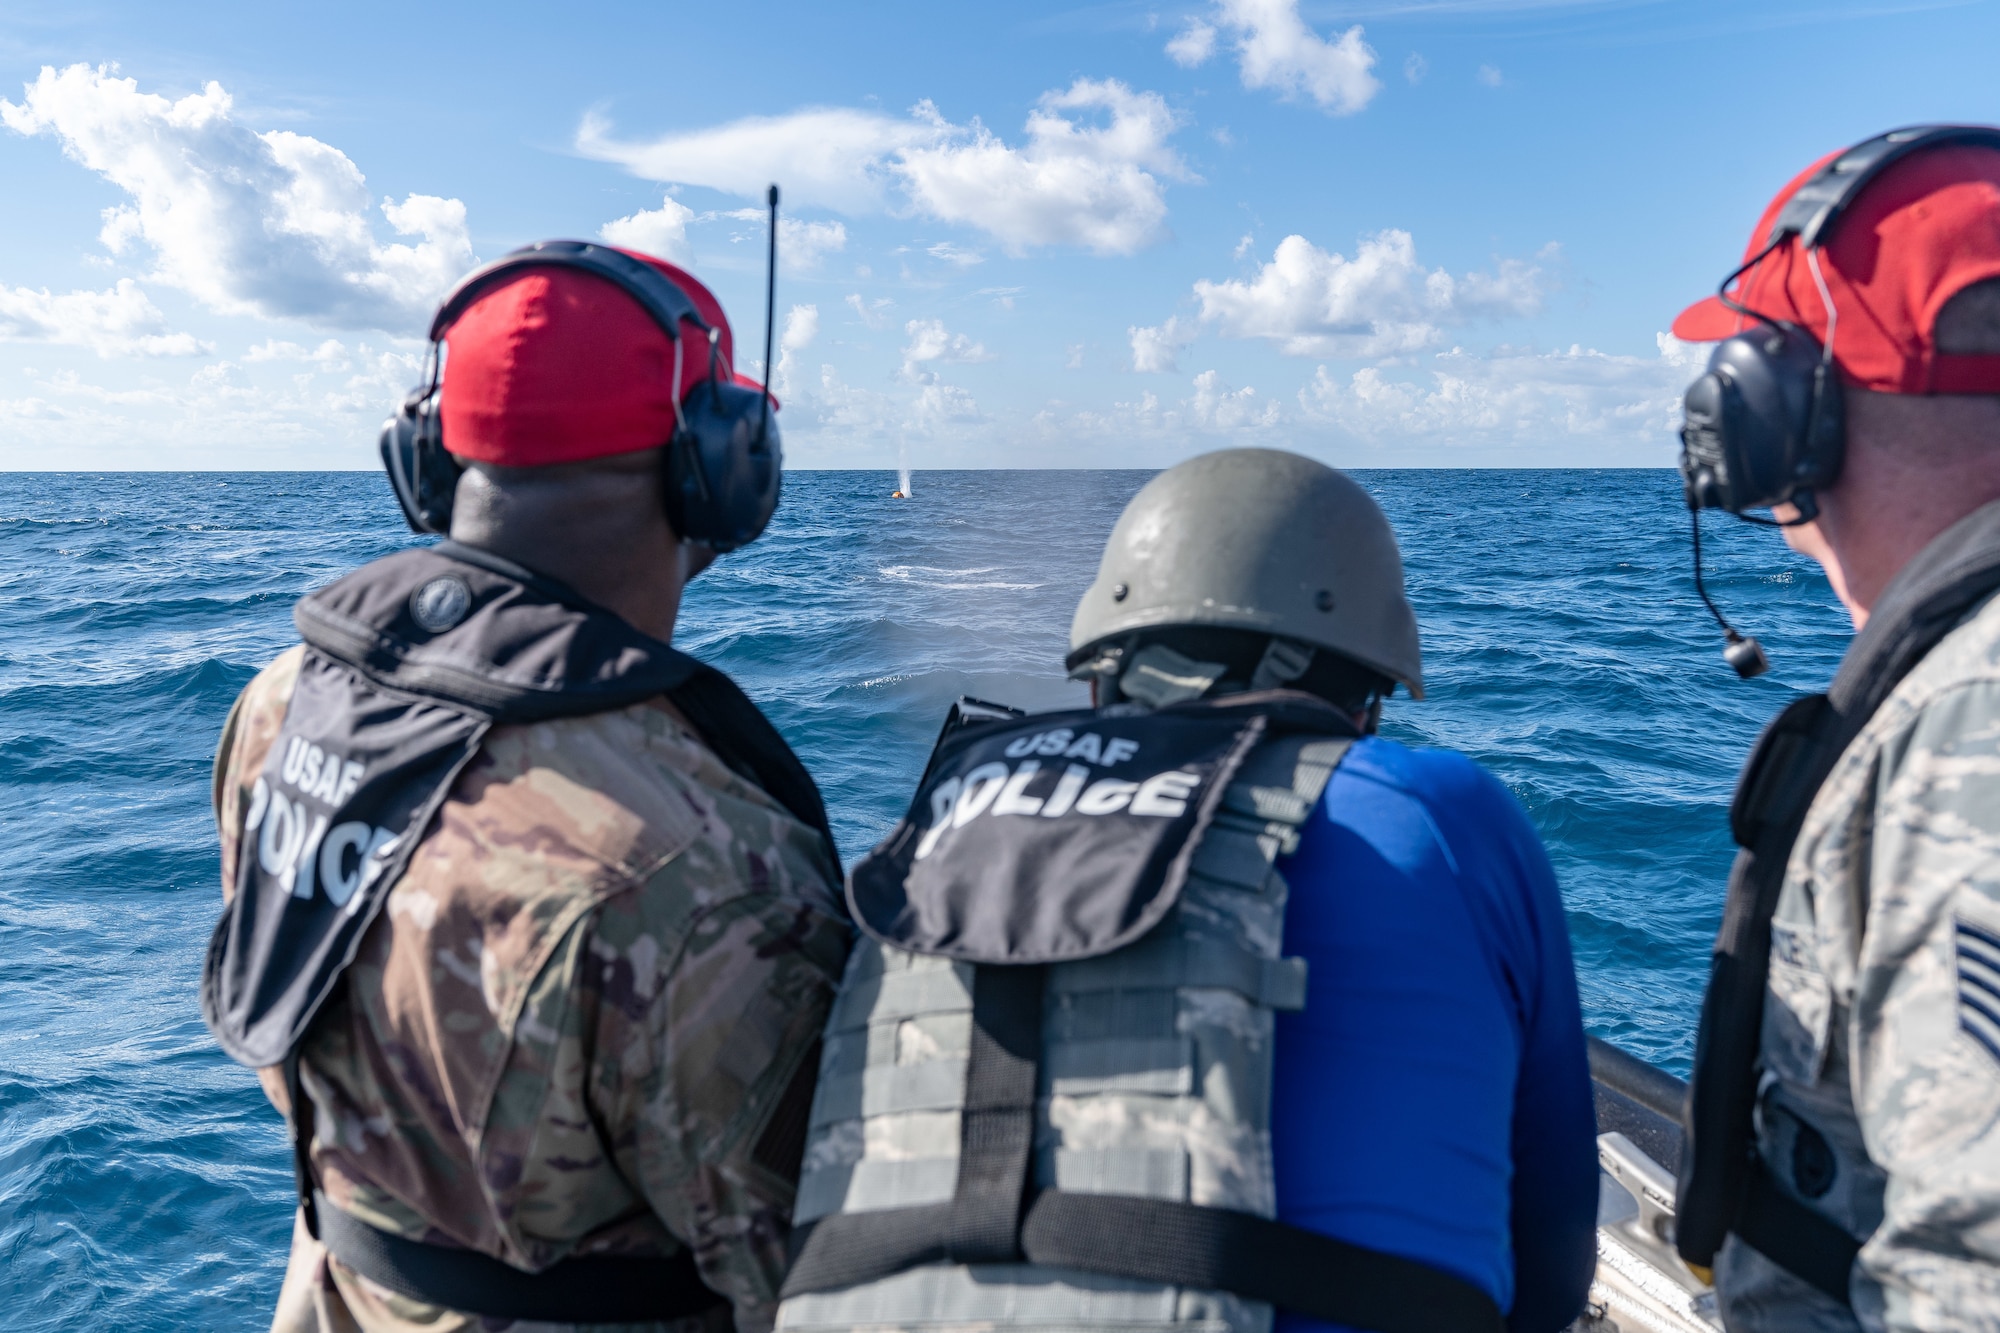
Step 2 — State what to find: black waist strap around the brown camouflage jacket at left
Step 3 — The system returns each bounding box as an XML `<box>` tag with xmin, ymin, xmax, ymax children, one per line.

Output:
<box><xmin>318</xmin><ymin>1195</ymin><xmax>722</xmax><ymax>1323</ymax></box>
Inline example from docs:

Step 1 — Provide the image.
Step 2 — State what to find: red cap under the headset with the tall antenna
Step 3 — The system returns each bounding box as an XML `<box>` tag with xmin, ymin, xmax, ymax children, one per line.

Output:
<box><xmin>442</xmin><ymin>250</ymin><xmax>762</xmax><ymax>466</ymax></box>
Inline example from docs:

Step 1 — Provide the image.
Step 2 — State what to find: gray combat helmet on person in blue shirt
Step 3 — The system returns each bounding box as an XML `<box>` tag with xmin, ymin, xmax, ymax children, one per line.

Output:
<box><xmin>1070</xmin><ymin>448</ymin><xmax>1424</xmax><ymax>699</ymax></box>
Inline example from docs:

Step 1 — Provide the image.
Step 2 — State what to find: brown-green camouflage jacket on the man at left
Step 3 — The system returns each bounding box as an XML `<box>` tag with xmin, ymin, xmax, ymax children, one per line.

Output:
<box><xmin>216</xmin><ymin>648</ymin><xmax>850</xmax><ymax>1333</ymax></box>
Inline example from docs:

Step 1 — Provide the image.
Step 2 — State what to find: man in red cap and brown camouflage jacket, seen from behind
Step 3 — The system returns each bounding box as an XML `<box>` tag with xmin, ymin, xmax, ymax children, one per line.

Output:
<box><xmin>204</xmin><ymin>242</ymin><xmax>848</xmax><ymax>1333</ymax></box>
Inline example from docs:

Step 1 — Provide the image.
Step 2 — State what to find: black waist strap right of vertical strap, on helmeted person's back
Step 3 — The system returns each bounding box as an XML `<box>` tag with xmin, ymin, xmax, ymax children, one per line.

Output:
<box><xmin>1022</xmin><ymin>1189</ymin><xmax>1506</xmax><ymax>1333</ymax></box>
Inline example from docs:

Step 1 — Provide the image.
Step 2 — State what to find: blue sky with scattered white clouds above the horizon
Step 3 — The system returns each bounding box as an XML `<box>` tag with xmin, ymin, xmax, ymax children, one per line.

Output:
<box><xmin>0</xmin><ymin>0</ymin><xmax>2000</xmax><ymax>470</ymax></box>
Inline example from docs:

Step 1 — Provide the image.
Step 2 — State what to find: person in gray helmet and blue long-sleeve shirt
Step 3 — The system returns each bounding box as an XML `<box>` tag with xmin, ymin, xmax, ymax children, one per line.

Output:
<box><xmin>778</xmin><ymin>448</ymin><xmax>1598</xmax><ymax>1333</ymax></box>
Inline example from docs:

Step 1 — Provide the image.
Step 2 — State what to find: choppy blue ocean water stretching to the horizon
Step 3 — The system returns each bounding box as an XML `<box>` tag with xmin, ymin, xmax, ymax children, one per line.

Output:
<box><xmin>0</xmin><ymin>470</ymin><xmax>1848</xmax><ymax>1333</ymax></box>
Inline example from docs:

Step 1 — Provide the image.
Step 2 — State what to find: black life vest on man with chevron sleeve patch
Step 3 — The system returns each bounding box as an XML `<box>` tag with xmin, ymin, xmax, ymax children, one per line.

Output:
<box><xmin>1674</xmin><ymin>502</ymin><xmax>2000</xmax><ymax>1303</ymax></box>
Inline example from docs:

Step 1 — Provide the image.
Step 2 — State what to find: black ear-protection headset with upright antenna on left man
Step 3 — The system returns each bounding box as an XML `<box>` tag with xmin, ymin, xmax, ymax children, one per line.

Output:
<box><xmin>382</xmin><ymin>186</ymin><xmax>784</xmax><ymax>550</ymax></box>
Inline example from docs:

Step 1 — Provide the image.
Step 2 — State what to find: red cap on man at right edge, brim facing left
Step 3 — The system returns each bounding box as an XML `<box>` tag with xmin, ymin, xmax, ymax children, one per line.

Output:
<box><xmin>1674</xmin><ymin>144</ymin><xmax>2000</xmax><ymax>394</ymax></box>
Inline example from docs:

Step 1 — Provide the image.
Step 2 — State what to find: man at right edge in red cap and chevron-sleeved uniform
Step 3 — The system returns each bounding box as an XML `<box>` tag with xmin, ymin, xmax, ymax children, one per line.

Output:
<box><xmin>1674</xmin><ymin>126</ymin><xmax>2000</xmax><ymax>1331</ymax></box>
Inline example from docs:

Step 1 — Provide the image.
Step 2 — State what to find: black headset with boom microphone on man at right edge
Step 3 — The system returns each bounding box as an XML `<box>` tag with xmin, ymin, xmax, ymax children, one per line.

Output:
<box><xmin>1680</xmin><ymin>124</ymin><xmax>2000</xmax><ymax>681</ymax></box>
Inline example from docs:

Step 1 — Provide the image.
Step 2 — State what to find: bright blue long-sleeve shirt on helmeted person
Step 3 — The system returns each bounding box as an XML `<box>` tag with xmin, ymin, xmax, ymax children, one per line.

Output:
<box><xmin>1272</xmin><ymin>737</ymin><xmax>1598</xmax><ymax>1333</ymax></box>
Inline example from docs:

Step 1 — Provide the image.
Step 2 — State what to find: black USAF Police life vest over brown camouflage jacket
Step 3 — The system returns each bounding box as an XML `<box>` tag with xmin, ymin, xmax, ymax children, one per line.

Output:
<box><xmin>202</xmin><ymin>542</ymin><xmax>838</xmax><ymax>1323</ymax></box>
